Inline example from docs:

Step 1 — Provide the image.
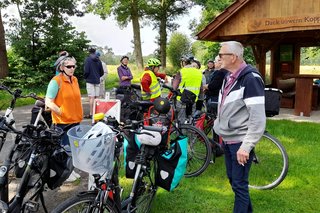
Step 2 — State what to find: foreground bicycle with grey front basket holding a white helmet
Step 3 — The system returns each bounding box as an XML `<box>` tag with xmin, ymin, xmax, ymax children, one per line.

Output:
<box><xmin>52</xmin><ymin>114</ymin><xmax>172</xmax><ymax>213</ymax></box>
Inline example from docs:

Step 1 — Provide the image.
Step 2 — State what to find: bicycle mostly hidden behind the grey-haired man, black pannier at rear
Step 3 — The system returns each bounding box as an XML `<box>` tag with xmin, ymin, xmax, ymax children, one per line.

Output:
<box><xmin>189</xmin><ymin>88</ymin><xmax>289</xmax><ymax>189</ymax></box>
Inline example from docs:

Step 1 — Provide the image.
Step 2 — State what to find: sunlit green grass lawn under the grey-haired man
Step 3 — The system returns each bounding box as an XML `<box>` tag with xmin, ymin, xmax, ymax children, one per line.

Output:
<box><xmin>121</xmin><ymin>120</ymin><xmax>320</xmax><ymax>213</ymax></box>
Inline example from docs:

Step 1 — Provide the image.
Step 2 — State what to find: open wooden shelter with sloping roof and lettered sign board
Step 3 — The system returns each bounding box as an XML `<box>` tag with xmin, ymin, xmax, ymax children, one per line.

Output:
<box><xmin>197</xmin><ymin>0</ymin><xmax>320</xmax><ymax>116</ymax></box>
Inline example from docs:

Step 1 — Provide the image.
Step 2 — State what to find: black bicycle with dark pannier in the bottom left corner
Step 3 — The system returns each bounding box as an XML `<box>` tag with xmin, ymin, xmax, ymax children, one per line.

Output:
<box><xmin>0</xmin><ymin>112</ymin><xmax>69</xmax><ymax>213</ymax></box>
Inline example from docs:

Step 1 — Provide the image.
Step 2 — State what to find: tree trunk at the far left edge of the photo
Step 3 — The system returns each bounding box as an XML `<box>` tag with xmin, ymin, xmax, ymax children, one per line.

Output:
<box><xmin>0</xmin><ymin>10</ymin><xmax>9</xmax><ymax>79</ymax></box>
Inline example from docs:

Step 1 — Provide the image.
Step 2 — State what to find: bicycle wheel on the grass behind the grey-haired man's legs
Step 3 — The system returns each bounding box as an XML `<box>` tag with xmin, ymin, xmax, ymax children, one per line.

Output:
<box><xmin>249</xmin><ymin>132</ymin><xmax>289</xmax><ymax>189</ymax></box>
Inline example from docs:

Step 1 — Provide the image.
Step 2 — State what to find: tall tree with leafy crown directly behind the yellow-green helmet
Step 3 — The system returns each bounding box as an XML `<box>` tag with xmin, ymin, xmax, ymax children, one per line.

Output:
<box><xmin>146</xmin><ymin>0</ymin><xmax>193</xmax><ymax>68</ymax></box>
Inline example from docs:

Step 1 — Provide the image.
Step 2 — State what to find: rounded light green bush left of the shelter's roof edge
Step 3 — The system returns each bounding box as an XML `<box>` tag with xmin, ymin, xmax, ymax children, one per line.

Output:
<box><xmin>167</xmin><ymin>32</ymin><xmax>191</xmax><ymax>68</ymax></box>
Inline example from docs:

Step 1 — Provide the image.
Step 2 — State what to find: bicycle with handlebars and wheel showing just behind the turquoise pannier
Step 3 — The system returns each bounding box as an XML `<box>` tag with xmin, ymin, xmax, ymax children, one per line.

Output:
<box><xmin>161</xmin><ymin>83</ymin><xmax>212</xmax><ymax>177</ymax></box>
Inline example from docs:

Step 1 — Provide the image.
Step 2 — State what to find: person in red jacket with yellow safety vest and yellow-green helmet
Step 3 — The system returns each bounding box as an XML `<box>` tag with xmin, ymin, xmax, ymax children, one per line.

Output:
<box><xmin>140</xmin><ymin>58</ymin><xmax>166</xmax><ymax>101</ymax></box>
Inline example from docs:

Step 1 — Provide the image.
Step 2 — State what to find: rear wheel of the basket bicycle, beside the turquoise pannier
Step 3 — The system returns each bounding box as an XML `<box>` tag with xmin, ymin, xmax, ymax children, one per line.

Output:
<box><xmin>132</xmin><ymin>161</ymin><xmax>157</xmax><ymax>213</ymax></box>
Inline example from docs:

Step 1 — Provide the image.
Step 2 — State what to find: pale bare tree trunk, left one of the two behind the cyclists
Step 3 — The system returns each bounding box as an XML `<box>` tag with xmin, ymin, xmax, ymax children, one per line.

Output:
<box><xmin>131</xmin><ymin>0</ymin><xmax>143</xmax><ymax>70</ymax></box>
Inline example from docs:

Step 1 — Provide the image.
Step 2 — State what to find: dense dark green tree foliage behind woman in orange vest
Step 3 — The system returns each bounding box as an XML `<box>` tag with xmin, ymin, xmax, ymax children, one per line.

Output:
<box><xmin>3</xmin><ymin>0</ymin><xmax>89</xmax><ymax>88</ymax></box>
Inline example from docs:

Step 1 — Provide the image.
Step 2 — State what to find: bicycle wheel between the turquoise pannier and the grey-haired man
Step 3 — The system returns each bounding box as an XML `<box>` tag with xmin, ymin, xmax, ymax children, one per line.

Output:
<box><xmin>170</xmin><ymin>124</ymin><xmax>212</xmax><ymax>177</ymax></box>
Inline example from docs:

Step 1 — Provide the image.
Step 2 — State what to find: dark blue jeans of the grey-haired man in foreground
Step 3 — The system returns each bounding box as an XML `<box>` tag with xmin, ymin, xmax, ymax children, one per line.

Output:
<box><xmin>224</xmin><ymin>143</ymin><xmax>253</xmax><ymax>213</ymax></box>
